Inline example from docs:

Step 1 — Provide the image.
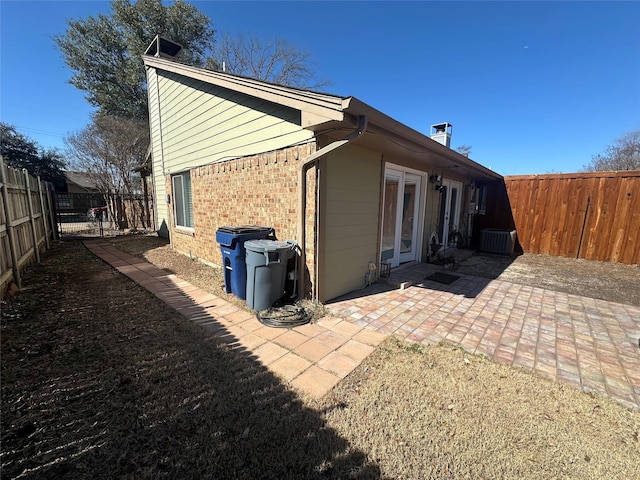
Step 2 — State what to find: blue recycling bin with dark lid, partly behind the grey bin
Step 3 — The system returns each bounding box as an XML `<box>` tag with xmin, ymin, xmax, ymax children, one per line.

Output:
<box><xmin>216</xmin><ymin>225</ymin><xmax>274</xmax><ymax>300</ymax></box>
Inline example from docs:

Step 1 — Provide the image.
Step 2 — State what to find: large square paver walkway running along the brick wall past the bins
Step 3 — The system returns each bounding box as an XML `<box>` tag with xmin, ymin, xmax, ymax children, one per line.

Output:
<box><xmin>85</xmin><ymin>240</ymin><xmax>385</xmax><ymax>398</ymax></box>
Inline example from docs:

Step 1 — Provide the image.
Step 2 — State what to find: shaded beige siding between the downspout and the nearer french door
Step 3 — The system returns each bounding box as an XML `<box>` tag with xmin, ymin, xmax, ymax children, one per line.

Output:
<box><xmin>319</xmin><ymin>145</ymin><xmax>382</xmax><ymax>301</ymax></box>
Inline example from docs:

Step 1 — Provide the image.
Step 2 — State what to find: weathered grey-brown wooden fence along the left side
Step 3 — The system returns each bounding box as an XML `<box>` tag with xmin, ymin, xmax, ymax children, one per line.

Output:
<box><xmin>0</xmin><ymin>156</ymin><xmax>57</xmax><ymax>298</ymax></box>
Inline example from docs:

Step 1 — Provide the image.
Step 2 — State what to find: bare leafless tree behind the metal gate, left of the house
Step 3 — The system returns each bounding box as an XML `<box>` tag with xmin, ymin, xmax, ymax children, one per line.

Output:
<box><xmin>65</xmin><ymin>114</ymin><xmax>149</xmax><ymax>228</ymax></box>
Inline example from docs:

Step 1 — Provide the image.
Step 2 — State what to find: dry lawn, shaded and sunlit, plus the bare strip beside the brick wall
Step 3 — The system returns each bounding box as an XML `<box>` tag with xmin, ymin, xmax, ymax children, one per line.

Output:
<box><xmin>0</xmin><ymin>237</ymin><xmax>640</xmax><ymax>479</ymax></box>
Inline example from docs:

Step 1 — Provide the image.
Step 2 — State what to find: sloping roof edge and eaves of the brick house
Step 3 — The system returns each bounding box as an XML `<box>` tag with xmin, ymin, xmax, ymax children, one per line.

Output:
<box><xmin>143</xmin><ymin>55</ymin><xmax>502</xmax><ymax>179</ymax></box>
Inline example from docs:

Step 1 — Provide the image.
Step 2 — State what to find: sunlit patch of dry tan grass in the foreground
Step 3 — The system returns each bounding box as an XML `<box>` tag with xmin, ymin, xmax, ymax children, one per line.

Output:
<box><xmin>326</xmin><ymin>341</ymin><xmax>640</xmax><ymax>479</ymax></box>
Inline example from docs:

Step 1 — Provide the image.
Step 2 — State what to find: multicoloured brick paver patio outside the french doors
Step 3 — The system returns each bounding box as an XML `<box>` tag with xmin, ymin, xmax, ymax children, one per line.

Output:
<box><xmin>327</xmin><ymin>266</ymin><xmax>640</xmax><ymax>408</ymax></box>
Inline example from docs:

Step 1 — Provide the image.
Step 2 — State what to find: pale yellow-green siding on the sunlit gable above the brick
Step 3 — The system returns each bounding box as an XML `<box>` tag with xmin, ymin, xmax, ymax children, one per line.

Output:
<box><xmin>148</xmin><ymin>69</ymin><xmax>313</xmax><ymax>236</ymax></box>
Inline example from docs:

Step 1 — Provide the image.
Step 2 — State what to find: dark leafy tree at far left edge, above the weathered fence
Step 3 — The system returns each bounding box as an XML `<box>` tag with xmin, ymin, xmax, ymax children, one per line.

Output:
<box><xmin>0</xmin><ymin>122</ymin><xmax>65</xmax><ymax>185</ymax></box>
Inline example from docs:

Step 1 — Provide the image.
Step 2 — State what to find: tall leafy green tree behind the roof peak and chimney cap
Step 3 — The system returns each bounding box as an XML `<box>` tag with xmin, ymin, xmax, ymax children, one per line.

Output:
<box><xmin>54</xmin><ymin>0</ymin><xmax>214</xmax><ymax>119</ymax></box>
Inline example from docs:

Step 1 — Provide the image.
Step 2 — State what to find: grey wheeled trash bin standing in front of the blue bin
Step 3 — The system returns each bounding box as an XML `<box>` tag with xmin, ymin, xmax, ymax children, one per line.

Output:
<box><xmin>245</xmin><ymin>240</ymin><xmax>297</xmax><ymax>311</ymax></box>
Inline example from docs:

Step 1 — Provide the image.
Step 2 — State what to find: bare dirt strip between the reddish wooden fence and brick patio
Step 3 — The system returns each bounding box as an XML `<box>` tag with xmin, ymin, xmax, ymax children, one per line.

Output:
<box><xmin>457</xmin><ymin>253</ymin><xmax>640</xmax><ymax>306</ymax></box>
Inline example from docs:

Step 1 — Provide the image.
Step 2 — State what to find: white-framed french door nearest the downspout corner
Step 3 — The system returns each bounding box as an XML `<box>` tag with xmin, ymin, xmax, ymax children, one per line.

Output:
<box><xmin>381</xmin><ymin>168</ymin><xmax>422</xmax><ymax>267</ymax></box>
